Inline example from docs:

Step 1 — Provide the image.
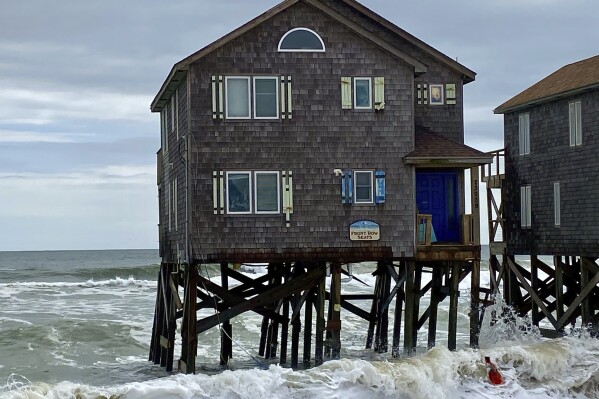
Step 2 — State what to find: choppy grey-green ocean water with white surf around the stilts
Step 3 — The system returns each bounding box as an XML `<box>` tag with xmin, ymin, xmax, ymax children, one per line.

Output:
<box><xmin>0</xmin><ymin>250</ymin><xmax>599</xmax><ymax>399</ymax></box>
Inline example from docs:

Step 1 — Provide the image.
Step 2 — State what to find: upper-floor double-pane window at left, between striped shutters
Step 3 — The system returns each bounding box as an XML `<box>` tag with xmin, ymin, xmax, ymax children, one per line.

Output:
<box><xmin>225</xmin><ymin>76</ymin><xmax>279</xmax><ymax>119</ymax></box>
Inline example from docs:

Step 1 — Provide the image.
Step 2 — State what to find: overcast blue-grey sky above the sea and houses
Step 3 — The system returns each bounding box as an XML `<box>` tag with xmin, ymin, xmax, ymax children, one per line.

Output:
<box><xmin>0</xmin><ymin>0</ymin><xmax>599</xmax><ymax>250</ymax></box>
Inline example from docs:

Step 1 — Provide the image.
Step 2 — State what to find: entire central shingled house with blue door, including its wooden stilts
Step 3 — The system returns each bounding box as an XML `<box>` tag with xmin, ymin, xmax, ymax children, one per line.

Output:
<box><xmin>150</xmin><ymin>0</ymin><xmax>491</xmax><ymax>373</ymax></box>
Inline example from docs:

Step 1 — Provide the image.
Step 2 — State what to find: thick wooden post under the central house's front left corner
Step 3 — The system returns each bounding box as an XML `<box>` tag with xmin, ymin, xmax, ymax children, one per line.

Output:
<box><xmin>179</xmin><ymin>263</ymin><xmax>198</xmax><ymax>374</ymax></box>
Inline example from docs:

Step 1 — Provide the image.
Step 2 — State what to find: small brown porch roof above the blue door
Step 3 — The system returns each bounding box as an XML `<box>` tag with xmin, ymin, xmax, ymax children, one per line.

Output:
<box><xmin>404</xmin><ymin>128</ymin><xmax>493</xmax><ymax>167</ymax></box>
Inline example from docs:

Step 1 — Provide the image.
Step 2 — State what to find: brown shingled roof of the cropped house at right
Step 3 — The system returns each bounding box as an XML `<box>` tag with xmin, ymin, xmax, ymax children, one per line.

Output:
<box><xmin>493</xmin><ymin>55</ymin><xmax>599</xmax><ymax>114</ymax></box>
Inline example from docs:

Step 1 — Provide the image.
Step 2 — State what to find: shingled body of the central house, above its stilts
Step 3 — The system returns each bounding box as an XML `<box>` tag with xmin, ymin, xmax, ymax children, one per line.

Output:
<box><xmin>151</xmin><ymin>0</ymin><xmax>492</xmax><ymax>263</ymax></box>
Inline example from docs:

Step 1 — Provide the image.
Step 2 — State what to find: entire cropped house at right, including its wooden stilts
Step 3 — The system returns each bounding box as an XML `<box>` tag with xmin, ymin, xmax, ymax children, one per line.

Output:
<box><xmin>483</xmin><ymin>56</ymin><xmax>599</xmax><ymax>336</ymax></box>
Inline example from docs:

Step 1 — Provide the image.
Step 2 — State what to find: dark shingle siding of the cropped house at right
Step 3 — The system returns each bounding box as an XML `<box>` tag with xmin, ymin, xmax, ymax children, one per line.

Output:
<box><xmin>504</xmin><ymin>91</ymin><xmax>599</xmax><ymax>256</ymax></box>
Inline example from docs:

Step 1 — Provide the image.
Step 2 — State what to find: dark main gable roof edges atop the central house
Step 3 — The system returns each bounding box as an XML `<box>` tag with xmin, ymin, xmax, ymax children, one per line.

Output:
<box><xmin>151</xmin><ymin>0</ymin><xmax>476</xmax><ymax>112</ymax></box>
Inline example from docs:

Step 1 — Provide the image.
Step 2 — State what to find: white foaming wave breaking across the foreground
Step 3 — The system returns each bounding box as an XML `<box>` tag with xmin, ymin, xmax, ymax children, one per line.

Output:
<box><xmin>0</xmin><ymin>337</ymin><xmax>599</xmax><ymax>399</ymax></box>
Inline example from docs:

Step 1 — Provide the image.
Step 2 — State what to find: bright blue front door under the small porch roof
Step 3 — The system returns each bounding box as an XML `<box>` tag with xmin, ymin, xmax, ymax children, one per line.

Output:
<box><xmin>416</xmin><ymin>171</ymin><xmax>460</xmax><ymax>242</ymax></box>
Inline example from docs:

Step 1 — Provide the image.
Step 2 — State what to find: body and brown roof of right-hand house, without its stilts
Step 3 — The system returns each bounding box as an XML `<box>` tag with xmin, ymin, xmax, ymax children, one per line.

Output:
<box><xmin>495</xmin><ymin>56</ymin><xmax>599</xmax><ymax>258</ymax></box>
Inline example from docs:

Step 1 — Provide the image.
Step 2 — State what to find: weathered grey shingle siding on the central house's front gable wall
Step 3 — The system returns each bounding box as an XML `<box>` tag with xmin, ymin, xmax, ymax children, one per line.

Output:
<box><xmin>190</xmin><ymin>3</ymin><xmax>414</xmax><ymax>261</ymax></box>
